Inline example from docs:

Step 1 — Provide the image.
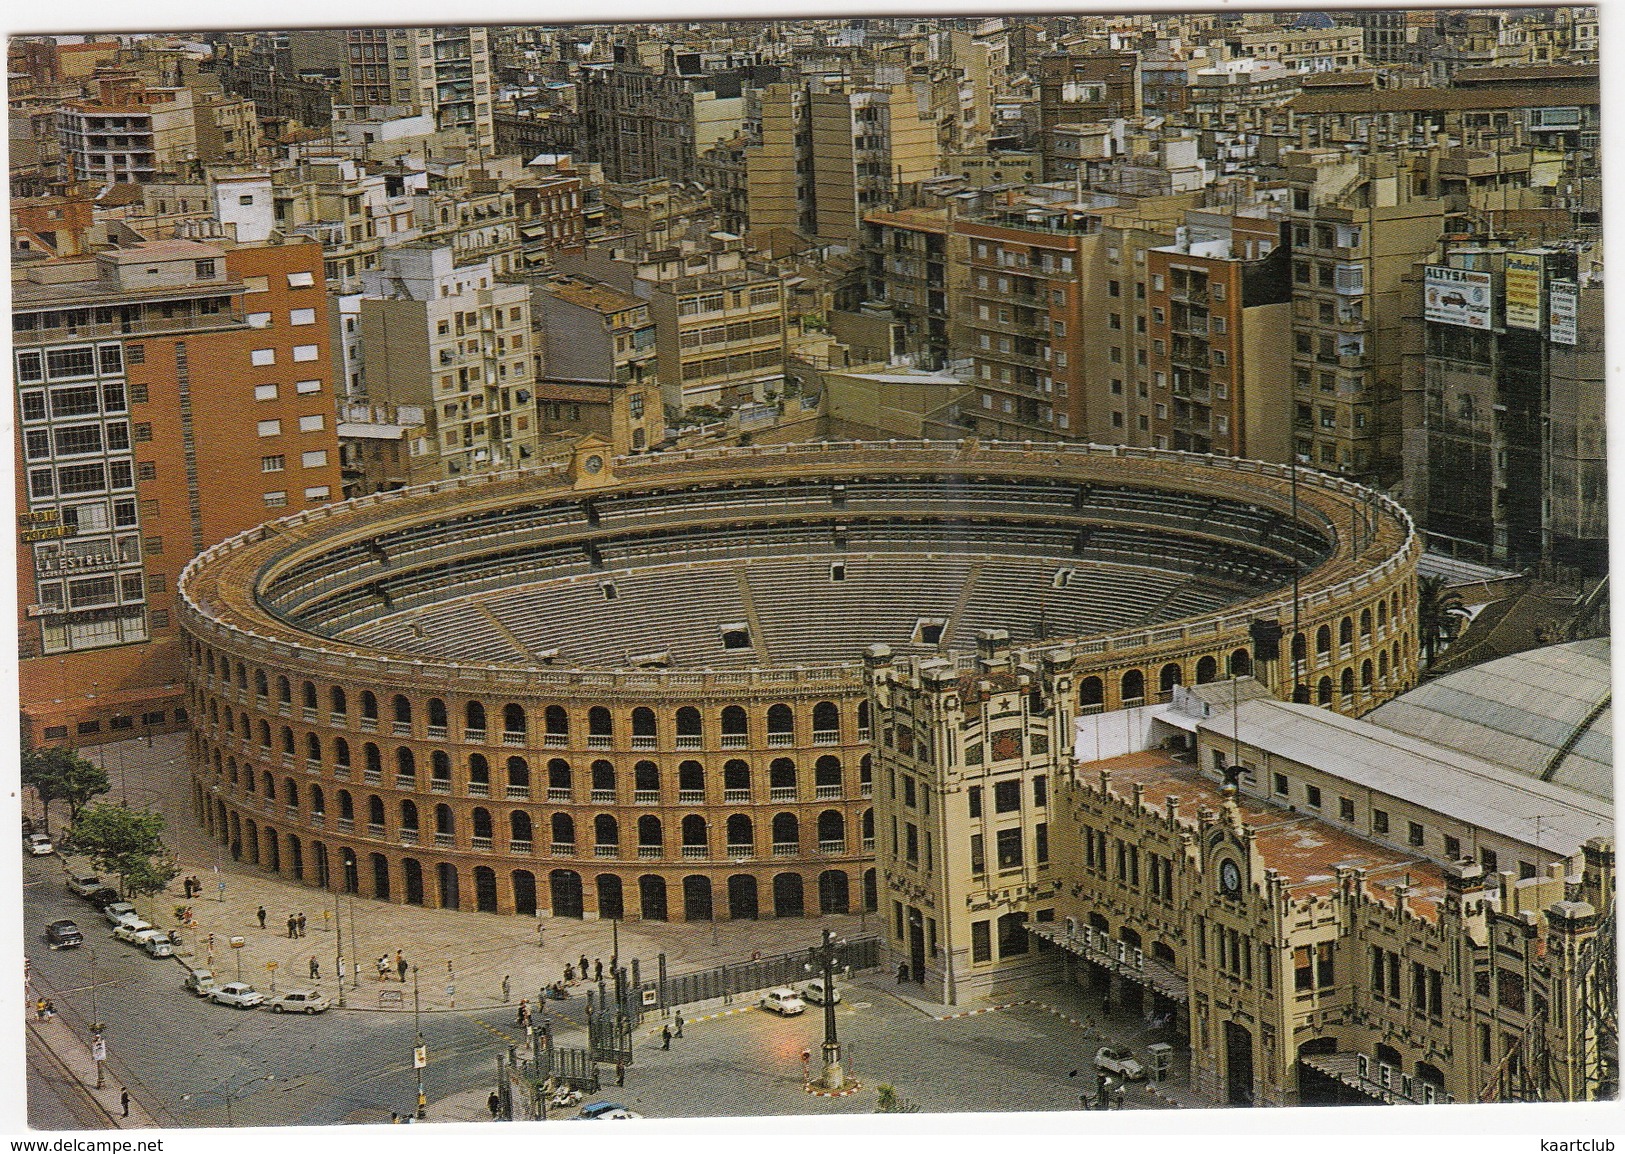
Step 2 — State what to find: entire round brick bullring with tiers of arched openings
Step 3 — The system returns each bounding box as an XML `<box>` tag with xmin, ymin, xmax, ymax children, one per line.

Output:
<box><xmin>180</xmin><ymin>442</ymin><xmax>1417</xmax><ymax>920</ymax></box>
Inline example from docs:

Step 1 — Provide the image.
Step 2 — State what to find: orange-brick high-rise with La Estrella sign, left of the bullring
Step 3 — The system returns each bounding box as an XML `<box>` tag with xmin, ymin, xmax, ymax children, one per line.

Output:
<box><xmin>13</xmin><ymin>241</ymin><xmax>341</xmax><ymax>741</ymax></box>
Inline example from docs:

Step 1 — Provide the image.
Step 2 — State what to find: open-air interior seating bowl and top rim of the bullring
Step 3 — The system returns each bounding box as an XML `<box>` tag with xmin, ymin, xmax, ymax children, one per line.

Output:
<box><xmin>180</xmin><ymin>440</ymin><xmax>1417</xmax><ymax>675</ymax></box>
